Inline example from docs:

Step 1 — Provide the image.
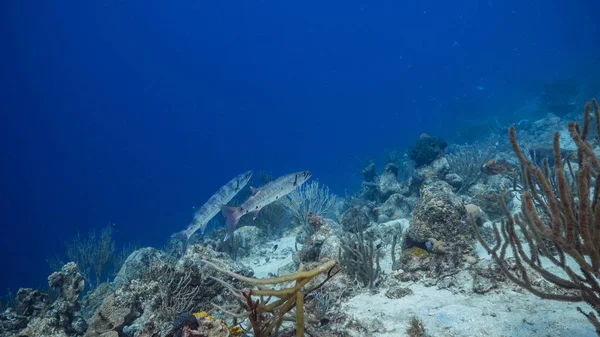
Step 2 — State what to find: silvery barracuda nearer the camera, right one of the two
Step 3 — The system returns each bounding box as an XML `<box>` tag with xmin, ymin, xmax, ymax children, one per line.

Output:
<box><xmin>221</xmin><ymin>171</ymin><xmax>312</xmax><ymax>241</ymax></box>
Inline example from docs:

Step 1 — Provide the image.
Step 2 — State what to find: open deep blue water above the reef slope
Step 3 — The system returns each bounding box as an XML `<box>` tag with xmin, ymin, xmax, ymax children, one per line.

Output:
<box><xmin>0</xmin><ymin>0</ymin><xmax>600</xmax><ymax>289</ymax></box>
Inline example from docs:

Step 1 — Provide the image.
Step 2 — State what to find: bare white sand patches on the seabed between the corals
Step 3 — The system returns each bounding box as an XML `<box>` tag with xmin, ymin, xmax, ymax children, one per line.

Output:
<box><xmin>242</xmin><ymin>237</ymin><xmax>596</xmax><ymax>337</ymax></box>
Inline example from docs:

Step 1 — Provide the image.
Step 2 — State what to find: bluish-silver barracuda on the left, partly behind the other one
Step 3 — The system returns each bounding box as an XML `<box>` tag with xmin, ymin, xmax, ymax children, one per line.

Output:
<box><xmin>171</xmin><ymin>171</ymin><xmax>252</xmax><ymax>249</ymax></box>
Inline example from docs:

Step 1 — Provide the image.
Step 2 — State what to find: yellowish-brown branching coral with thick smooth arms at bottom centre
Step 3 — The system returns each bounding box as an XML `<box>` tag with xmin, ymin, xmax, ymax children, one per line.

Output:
<box><xmin>204</xmin><ymin>261</ymin><xmax>339</xmax><ymax>337</ymax></box>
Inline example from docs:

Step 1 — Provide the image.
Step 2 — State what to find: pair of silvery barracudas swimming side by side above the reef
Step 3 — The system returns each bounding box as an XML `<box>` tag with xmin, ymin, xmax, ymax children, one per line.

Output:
<box><xmin>172</xmin><ymin>171</ymin><xmax>312</xmax><ymax>252</ymax></box>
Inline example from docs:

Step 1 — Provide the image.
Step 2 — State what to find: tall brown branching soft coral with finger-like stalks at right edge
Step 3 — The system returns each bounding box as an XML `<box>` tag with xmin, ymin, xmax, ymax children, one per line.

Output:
<box><xmin>472</xmin><ymin>100</ymin><xmax>600</xmax><ymax>336</ymax></box>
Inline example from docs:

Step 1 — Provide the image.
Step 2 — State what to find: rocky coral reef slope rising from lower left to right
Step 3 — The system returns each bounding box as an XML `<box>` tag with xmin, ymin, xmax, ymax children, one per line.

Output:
<box><xmin>0</xmin><ymin>101</ymin><xmax>600</xmax><ymax>337</ymax></box>
